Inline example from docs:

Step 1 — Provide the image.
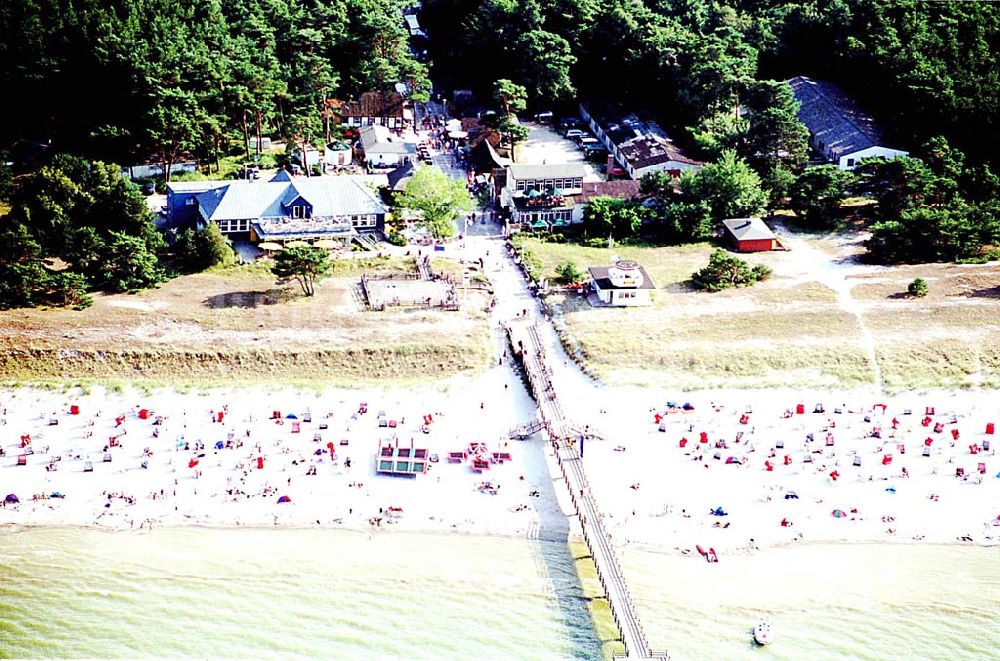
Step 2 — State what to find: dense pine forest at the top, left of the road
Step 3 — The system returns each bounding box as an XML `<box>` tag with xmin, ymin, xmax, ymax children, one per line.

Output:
<box><xmin>0</xmin><ymin>0</ymin><xmax>428</xmax><ymax>173</ymax></box>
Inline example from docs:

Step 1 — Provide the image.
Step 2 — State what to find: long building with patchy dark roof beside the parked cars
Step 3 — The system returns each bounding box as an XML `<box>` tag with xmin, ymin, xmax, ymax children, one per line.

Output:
<box><xmin>580</xmin><ymin>103</ymin><xmax>704</xmax><ymax>179</ymax></box>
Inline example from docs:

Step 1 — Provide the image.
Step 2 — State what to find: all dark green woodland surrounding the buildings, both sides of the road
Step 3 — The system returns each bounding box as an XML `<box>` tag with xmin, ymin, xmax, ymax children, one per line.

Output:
<box><xmin>0</xmin><ymin>0</ymin><xmax>1000</xmax><ymax>307</ymax></box>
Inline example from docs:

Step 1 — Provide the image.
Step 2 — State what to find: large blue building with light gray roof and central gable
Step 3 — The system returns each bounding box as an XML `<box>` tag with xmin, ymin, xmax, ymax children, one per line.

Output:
<box><xmin>167</xmin><ymin>171</ymin><xmax>388</xmax><ymax>242</ymax></box>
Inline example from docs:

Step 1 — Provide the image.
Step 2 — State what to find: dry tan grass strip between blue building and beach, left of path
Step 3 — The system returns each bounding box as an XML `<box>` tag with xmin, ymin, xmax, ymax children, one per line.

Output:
<box><xmin>0</xmin><ymin>257</ymin><xmax>491</xmax><ymax>387</ymax></box>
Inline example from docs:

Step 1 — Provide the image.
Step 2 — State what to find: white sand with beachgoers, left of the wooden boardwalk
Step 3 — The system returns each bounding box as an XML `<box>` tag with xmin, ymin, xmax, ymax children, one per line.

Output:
<box><xmin>0</xmin><ymin>368</ymin><xmax>565</xmax><ymax>534</ymax></box>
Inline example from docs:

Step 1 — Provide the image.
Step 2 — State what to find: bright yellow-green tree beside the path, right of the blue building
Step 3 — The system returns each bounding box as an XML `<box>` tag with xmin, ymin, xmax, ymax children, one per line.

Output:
<box><xmin>397</xmin><ymin>165</ymin><xmax>473</xmax><ymax>239</ymax></box>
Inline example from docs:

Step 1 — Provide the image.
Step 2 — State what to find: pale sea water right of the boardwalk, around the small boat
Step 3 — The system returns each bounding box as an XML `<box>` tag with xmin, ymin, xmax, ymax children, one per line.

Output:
<box><xmin>623</xmin><ymin>544</ymin><xmax>1000</xmax><ymax>661</ymax></box>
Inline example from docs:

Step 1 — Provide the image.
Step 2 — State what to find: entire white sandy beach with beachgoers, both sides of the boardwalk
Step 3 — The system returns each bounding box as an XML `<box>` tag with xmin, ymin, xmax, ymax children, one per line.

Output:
<box><xmin>0</xmin><ymin>372</ymin><xmax>1000</xmax><ymax>556</ymax></box>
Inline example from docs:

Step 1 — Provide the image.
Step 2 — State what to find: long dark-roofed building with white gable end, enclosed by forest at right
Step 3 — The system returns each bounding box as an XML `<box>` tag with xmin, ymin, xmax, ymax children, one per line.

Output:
<box><xmin>788</xmin><ymin>76</ymin><xmax>909</xmax><ymax>170</ymax></box>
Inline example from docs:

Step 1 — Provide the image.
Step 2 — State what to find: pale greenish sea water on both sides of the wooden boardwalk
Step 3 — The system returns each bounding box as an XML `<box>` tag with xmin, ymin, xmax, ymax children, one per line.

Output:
<box><xmin>0</xmin><ymin>528</ymin><xmax>1000</xmax><ymax>661</ymax></box>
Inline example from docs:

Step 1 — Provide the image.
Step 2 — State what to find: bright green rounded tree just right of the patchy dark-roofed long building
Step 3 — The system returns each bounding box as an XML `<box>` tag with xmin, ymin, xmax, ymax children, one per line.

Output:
<box><xmin>681</xmin><ymin>149</ymin><xmax>767</xmax><ymax>221</ymax></box>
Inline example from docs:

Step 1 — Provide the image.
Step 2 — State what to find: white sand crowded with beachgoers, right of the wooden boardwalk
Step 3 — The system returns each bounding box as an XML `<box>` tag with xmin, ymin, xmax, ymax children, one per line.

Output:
<box><xmin>572</xmin><ymin>389</ymin><xmax>1000</xmax><ymax>554</ymax></box>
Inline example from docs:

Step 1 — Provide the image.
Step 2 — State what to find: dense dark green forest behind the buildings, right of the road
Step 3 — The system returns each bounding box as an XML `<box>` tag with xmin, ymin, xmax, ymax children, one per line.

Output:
<box><xmin>422</xmin><ymin>0</ymin><xmax>1000</xmax><ymax>165</ymax></box>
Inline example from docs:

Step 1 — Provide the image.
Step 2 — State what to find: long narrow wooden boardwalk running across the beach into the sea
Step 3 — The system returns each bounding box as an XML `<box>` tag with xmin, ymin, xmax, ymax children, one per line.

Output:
<box><xmin>506</xmin><ymin>322</ymin><xmax>668</xmax><ymax>659</ymax></box>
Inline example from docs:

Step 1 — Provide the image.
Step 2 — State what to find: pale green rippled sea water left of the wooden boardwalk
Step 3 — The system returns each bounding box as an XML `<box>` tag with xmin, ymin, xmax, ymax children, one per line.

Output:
<box><xmin>0</xmin><ymin>528</ymin><xmax>600</xmax><ymax>659</ymax></box>
